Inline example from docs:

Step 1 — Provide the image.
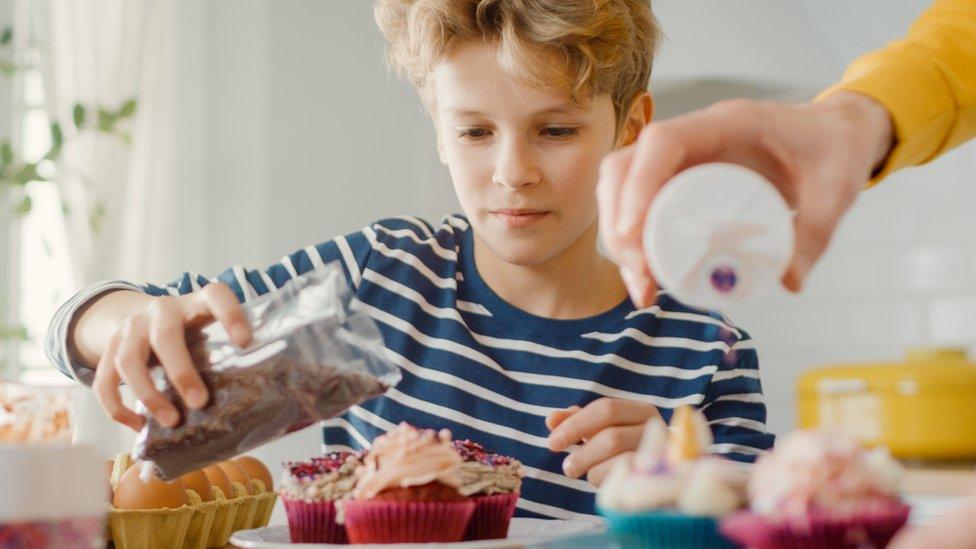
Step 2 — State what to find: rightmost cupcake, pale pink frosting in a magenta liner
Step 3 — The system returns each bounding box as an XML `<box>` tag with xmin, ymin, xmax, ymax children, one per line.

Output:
<box><xmin>722</xmin><ymin>431</ymin><xmax>909</xmax><ymax>549</ymax></box>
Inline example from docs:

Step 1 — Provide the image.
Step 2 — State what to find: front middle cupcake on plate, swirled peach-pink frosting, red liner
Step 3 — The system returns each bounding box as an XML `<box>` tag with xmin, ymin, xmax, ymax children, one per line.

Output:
<box><xmin>340</xmin><ymin>423</ymin><xmax>475</xmax><ymax>543</ymax></box>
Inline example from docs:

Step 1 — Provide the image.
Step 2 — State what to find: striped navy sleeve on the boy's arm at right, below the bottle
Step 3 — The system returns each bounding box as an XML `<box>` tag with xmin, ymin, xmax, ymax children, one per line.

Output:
<box><xmin>702</xmin><ymin>332</ymin><xmax>774</xmax><ymax>462</ymax></box>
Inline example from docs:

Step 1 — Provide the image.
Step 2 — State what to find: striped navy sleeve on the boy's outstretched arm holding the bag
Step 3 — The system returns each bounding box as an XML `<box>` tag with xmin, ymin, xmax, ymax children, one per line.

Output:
<box><xmin>45</xmin><ymin>228</ymin><xmax>372</xmax><ymax>386</ymax></box>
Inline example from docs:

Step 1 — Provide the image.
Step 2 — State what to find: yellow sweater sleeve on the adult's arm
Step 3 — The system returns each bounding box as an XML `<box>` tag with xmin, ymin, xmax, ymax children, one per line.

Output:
<box><xmin>819</xmin><ymin>0</ymin><xmax>976</xmax><ymax>184</ymax></box>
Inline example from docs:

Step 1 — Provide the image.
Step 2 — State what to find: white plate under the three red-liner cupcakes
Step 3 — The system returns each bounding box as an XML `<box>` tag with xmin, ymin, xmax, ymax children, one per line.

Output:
<box><xmin>230</xmin><ymin>518</ymin><xmax>606</xmax><ymax>549</ymax></box>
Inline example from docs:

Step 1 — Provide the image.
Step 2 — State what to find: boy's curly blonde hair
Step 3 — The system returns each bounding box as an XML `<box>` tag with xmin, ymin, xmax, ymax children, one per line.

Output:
<box><xmin>374</xmin><ymin>0</ymin><xmax>661</xmax><ymax>130</ymax></box>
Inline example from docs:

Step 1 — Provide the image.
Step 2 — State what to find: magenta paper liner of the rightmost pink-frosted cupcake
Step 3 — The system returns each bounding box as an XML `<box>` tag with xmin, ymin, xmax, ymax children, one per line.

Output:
<box><xmin>720</xmin><ymin>504</ymin><xmax>910</xmax><ymax>549</ymax></box>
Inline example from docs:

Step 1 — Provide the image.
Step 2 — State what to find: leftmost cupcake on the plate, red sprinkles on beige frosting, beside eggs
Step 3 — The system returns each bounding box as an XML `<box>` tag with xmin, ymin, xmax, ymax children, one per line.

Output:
<box><xmin>281</xmin><ymin>452</ymin><xmax>364</xmax><ymax>543</ymax></box>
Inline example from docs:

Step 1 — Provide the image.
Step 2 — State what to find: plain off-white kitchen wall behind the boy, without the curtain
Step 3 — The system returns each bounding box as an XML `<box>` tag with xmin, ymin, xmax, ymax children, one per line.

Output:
<box><xmin>198</xmin><ymin>0</ymin><xmax>976</xmax><ymax>520</ymax></box>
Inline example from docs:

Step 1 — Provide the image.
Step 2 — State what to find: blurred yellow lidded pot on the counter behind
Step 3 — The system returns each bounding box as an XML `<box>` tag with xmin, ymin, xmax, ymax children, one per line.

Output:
<box><xmin>798</xmin><ymin>348</ymin><xmax>976</xmax><ymax>460</ymax></box>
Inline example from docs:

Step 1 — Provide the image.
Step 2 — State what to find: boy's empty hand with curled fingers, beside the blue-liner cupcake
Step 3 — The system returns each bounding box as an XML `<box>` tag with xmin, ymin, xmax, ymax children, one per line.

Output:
<box><xmin>546</xmin><ymin>398</ymin><xmax>660</xmax><ymax>486</ymax></box>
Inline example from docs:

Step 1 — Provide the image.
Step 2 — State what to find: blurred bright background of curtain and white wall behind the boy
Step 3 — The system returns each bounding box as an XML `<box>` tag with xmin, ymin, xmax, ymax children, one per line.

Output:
<box><xmin>0</xmin><ymin>0</ymin><xmax>976</xmax><ymax>512</ymax></box>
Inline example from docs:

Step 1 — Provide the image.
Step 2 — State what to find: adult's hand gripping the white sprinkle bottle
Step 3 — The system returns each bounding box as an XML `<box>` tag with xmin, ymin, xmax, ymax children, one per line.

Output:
<box><xmin>597</xmin><ymin>91</ymin><xmax>893</xmax><ymax>307</ymax></box>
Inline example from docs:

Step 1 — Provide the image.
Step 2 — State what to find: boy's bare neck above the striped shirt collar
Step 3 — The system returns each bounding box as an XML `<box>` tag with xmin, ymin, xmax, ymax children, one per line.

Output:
<box><xmin>474</xmin><ymin>222</ymin><xmax>627</xmax><ymax>320</ymax></box>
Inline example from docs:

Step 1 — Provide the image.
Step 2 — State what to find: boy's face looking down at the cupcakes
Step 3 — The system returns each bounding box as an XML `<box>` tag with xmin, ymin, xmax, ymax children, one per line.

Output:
<box><xmin>430</xmin><ymin>42</ymin><xmax>615</xmax><ymax>266</ymax></box>
